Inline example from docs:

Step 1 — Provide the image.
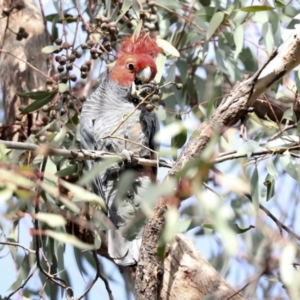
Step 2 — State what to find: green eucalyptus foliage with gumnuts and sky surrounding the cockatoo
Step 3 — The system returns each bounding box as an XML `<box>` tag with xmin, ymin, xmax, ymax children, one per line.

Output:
<box><xmin>0</xmin><ymin>0</ymin><xmax>300</xmax><ymax>299</ymax></box>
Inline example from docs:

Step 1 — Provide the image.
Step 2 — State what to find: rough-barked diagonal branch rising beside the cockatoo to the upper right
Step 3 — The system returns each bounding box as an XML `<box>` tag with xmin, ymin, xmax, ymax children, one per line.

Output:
<box><xmin>135</xmin><ymin>21</ymin><xmax>300</xmax><ymax>300</ymax></box>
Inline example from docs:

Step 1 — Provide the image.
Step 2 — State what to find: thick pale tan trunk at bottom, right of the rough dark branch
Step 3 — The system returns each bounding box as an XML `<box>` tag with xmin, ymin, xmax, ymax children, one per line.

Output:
<box><xmin>161</xmin><ymin>234</ymin><xmax>245</xmax><ymax>300</ymax></box>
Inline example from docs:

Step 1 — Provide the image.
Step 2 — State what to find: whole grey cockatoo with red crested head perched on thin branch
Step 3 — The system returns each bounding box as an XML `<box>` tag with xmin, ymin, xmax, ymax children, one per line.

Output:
<box><xmin>80</xmin><ymin>33</ymin><xmax>161</xmax><ymax>266</ymax></box>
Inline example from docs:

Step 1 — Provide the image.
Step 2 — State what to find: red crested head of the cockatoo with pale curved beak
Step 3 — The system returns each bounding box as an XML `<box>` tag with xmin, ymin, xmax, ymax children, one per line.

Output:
<box><xmin>110</xmin><ymin>33</ymin><xmax>161</xmax><ymax>87</ymax></box>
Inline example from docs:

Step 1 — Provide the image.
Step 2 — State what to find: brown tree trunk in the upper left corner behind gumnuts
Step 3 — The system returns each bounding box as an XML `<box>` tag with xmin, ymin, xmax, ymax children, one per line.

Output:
<box><xmin>0</xmin><ymin>0</ymin><xmax>49</xmax><ymax>141</ymax></box>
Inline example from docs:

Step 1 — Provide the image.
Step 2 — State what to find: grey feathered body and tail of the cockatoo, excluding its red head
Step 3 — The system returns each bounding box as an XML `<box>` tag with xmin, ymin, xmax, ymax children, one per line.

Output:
<box><xmin>80</xmin><ymin>77</ymin><xmax>159</xmax><ymax>266</ymax></box>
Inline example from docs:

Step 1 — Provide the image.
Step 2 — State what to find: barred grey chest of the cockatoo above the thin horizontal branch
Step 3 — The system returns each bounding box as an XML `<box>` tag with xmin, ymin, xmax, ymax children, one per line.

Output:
<box><xmin>81</xmin><ymin>79</ymin><xmax>158</xmax><ymax>157</ymax></box>
